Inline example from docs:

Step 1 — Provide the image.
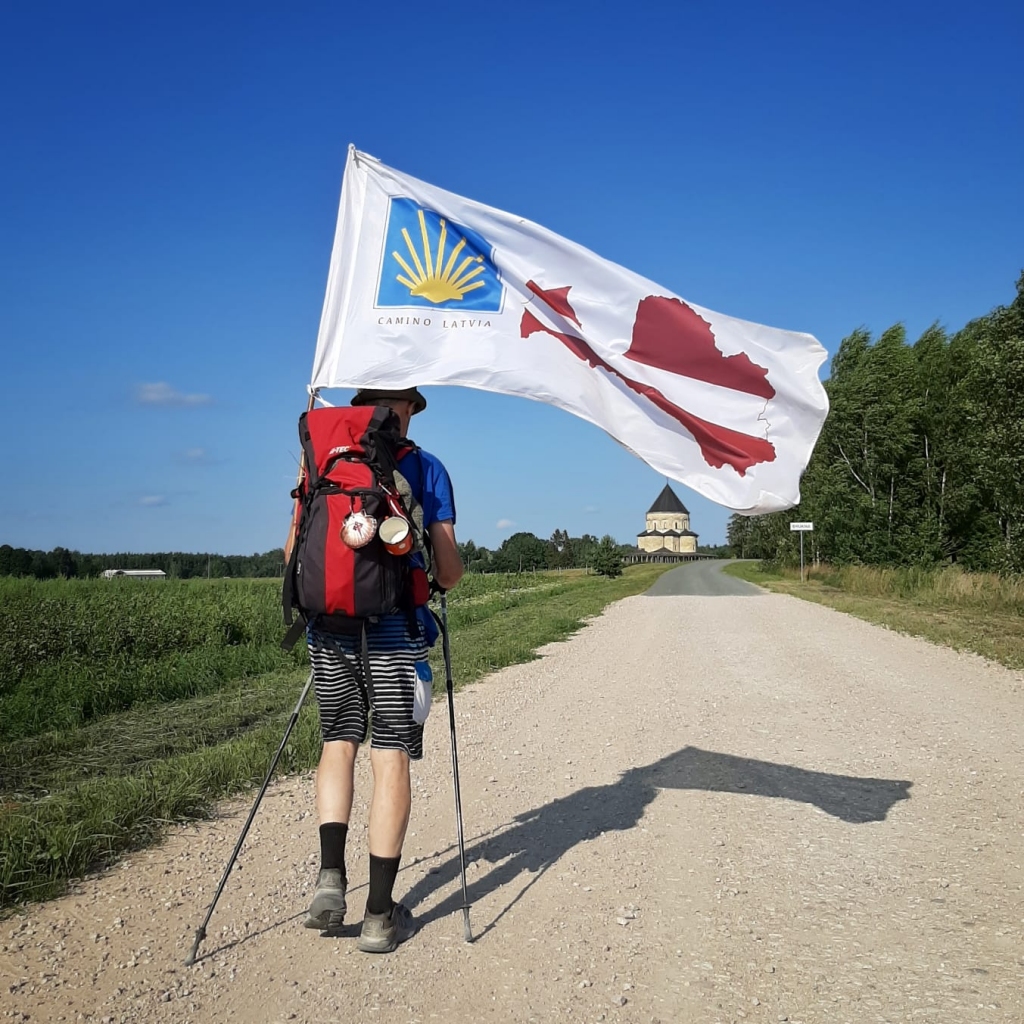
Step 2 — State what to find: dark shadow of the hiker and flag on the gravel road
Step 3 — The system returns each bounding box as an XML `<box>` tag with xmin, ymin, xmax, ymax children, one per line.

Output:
<box><xmin>402</xmin><ymin>746</ymin><xmax>913</xmax><ymax>934</ymax></box>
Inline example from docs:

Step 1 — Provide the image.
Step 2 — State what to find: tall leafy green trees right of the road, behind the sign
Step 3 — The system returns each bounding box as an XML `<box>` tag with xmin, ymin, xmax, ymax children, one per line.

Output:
<box><xmin>728</xmin><ymin>273</ymin><xmax>1024</xmax><ymax>572</ymax></box>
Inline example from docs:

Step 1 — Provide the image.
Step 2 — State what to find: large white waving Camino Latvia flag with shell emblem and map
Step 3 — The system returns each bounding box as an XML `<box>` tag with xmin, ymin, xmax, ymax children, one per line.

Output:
<box><xmin>310</xmin><ymin>147</ymin><xmax>828</xmax><ymax>515</ymax></box>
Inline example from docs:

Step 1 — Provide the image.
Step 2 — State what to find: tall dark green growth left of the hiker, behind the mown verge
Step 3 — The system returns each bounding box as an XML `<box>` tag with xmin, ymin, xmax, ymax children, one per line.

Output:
<box><xmin>0</xmin><ymin>579</ymin><xmax>303</xmax><ymax>739</ymax></box>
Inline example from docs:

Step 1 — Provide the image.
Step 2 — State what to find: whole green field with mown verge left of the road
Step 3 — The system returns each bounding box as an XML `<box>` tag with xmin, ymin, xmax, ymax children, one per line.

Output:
<box><xmin>0</xmin><ymin>565</ymin><xmax>671</xmax><ymax>910</ymax></box>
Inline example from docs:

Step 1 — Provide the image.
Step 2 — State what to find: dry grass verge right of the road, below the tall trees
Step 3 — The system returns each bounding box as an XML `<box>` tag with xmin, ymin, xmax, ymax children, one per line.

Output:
<box><xmin>725</xmin><ymin>562</ymin><xmax>1024</xmax><ymax>669</ymax></box>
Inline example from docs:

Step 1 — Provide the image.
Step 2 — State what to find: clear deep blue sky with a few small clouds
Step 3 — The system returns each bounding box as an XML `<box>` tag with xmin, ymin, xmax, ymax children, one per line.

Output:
<box><xmin>0</xmin><ymin>0</ymin><xmax>1024</xmax><ymax>554</ymax></box>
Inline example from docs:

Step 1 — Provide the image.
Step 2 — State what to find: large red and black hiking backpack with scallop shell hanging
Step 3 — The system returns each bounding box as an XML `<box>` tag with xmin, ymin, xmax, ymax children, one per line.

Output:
<box><xmin>282</xmin><ymin>406</ymin><xmax>429</xmax><ymax>647</ymax></box>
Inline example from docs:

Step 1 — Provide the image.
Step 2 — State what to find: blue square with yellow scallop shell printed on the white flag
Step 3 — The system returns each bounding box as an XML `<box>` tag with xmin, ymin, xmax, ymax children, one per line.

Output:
<box><xmin>377</xmin><ymin>197</ymin><xmax>505</xmax><ymax>312</ymax></box>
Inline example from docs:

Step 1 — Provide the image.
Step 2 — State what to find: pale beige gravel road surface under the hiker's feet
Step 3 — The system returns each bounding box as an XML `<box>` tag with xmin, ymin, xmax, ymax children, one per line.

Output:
<box><xmin>0</xmin><ymin>581</ymin><xmax>1024</xmax><ymax>1024</ymax></box>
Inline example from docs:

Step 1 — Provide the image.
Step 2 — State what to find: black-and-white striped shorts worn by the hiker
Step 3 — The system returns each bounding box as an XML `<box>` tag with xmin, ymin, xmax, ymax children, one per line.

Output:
<box><xmin>306</xmin><ymin>615</ymin><xmax>427</xmax><ymax>761</ymax></box>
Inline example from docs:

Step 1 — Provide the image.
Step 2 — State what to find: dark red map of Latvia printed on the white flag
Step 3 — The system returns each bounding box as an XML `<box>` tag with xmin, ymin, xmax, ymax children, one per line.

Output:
<box><xmin>519</xmin><ymin>281</ymin><xmax>775</xmax><ymax>476</ymax></box>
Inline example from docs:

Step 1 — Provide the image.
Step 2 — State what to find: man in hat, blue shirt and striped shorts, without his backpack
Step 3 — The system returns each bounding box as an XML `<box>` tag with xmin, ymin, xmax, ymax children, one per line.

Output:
<box><xmin>305</xmin><ymin>388</ymin><xmax>463</xmax><ymax>953</ymax></box>
